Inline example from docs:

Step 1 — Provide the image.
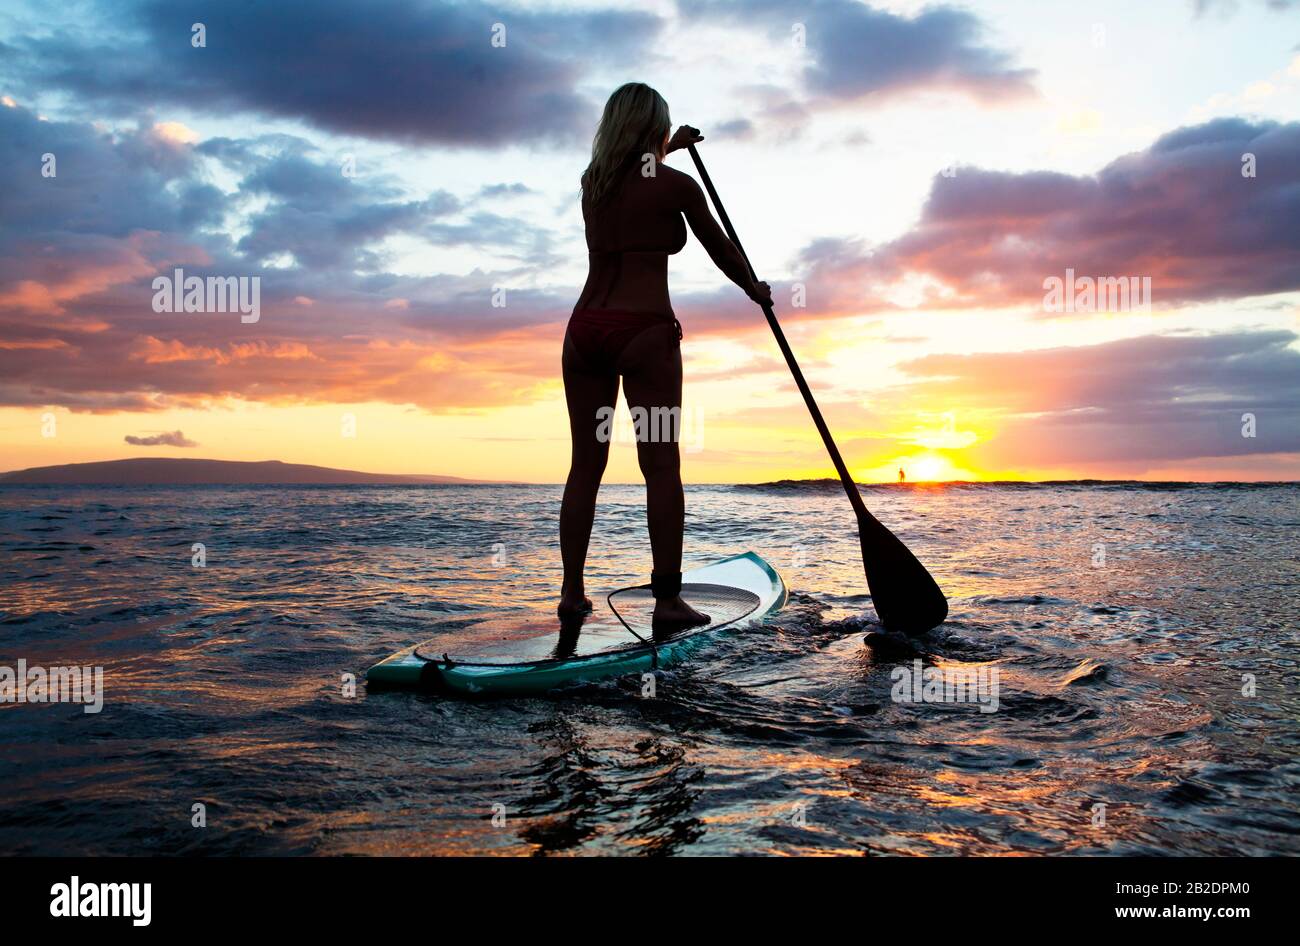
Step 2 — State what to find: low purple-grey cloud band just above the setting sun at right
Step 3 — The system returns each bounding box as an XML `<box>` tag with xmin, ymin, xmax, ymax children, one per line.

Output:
<box><xmin>900</xmin><ymin>331</ymin><xmax>1300</xmax><ymax>467</ymax></box>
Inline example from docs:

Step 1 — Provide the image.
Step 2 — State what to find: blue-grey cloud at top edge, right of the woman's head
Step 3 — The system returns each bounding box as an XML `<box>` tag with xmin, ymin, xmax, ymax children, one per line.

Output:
<box><xmin>680</xmin><ymin>0</ymin><xmax>1034</xmax><ymax>105</ymax></box>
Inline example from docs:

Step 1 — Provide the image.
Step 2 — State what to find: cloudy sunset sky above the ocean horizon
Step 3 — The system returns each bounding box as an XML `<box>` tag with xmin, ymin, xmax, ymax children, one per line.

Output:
<box><xmin>0</xmin><ymin>0</ymin><xmax>1300</xmax><ymax>482</ymax></box>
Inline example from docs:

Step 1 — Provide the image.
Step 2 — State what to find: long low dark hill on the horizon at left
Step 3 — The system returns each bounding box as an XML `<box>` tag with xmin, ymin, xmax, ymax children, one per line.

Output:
<box><xmin>0</xmin><ymin>457</ymin><xmax>499</xmax><ymax>486</ymax></box>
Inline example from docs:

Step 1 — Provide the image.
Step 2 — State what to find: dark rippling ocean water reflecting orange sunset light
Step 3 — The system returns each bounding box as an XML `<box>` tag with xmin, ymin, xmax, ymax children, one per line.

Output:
<box><xmin>0</xmin><ymin>483</ymin><xmax>1300</xmax><ymax>855</ymax></box>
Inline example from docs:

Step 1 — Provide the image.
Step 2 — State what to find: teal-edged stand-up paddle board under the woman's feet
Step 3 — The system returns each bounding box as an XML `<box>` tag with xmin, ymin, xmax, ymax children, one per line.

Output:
<box><xmin>365</xmin><ymin>552</ymin><xmax>787</xmax><ymax>695</ymax></box>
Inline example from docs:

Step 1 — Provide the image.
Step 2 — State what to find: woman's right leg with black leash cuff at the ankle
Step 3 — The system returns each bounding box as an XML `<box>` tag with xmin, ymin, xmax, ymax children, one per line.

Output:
<box><xmin>619</xmin><ymin>324</ymin><xmax>709</xmax><ymax>624</ymax></box>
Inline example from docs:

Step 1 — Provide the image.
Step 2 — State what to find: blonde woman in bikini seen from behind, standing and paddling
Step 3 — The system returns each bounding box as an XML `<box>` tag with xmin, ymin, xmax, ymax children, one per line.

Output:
<box><xmin>559</xmin><ymin>82</ymin><xmax>771</xmax><ymax>625</ymax></box>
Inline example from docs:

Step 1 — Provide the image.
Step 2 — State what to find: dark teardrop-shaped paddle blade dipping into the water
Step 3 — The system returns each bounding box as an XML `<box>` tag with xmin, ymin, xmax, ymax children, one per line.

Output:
<box><xmin>858</xmin><ymin>512</ymin><xmax>948</xmax><ymax>634</ymax></box>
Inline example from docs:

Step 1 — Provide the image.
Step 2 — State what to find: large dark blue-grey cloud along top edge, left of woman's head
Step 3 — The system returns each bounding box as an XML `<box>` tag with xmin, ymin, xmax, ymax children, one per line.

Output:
<box><xmin>0</xmin><ymin>0</ymin><xmax>662</xmax><ymax>146</ymax></box>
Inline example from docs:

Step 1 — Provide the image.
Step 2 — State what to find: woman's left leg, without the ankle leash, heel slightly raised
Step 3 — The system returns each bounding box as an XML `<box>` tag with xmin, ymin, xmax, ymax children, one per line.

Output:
<box><xmin>558</xmin><ymin>337</ymin><xmax>619</xmax><ymax>617</ymax></box>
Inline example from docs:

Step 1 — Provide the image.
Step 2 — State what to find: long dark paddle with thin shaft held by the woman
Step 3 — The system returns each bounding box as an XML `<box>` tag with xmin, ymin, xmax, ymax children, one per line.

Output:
<box><xmin>686</xmin><ymin>144</ymin><xmax>948</xmax><ymax>634</ymax></box>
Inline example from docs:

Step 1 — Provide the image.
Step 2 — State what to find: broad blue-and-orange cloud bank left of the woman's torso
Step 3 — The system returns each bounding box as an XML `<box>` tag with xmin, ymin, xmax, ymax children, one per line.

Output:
<box><xmin>0</xmin><ymin>98</ymin><xmax>572</xmax><ymax>412</ymax></box>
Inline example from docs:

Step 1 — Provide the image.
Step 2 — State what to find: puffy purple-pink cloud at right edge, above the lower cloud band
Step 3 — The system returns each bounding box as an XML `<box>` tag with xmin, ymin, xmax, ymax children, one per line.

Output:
<box><xmin>801</xmin><ymin>118</ymin><xmax>1300</xmax><ymax>311</ymax></box>
